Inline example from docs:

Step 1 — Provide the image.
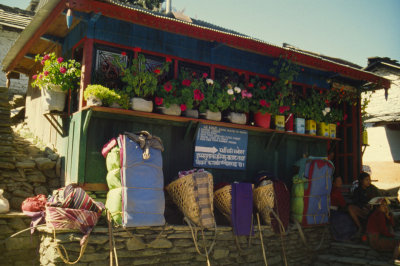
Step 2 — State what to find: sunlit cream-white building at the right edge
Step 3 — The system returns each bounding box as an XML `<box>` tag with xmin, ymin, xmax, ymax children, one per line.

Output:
<box><xmin>363</xmin><ymin>57</ymin><xmax>400</xmax><ymax>188</ymax></box>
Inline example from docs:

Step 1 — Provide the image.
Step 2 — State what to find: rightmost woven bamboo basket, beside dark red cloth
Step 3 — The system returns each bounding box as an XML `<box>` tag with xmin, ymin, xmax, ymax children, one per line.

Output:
<box><xmin>253</xmin><ymin>183</ymin><xmax>274</xmax><ymax>225</ymax></box>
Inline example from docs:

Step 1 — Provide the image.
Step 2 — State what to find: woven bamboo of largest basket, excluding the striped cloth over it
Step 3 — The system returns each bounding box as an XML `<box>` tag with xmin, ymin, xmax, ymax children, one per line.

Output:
<box><xmin>166</xmin><ymin>173</ymin><xmax>214</xmax><ymax>226</ymax></box>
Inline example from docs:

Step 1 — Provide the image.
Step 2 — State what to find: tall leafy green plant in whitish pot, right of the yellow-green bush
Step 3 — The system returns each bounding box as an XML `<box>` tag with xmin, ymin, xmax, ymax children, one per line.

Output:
<box><xmin>114</xmin><ymin>52</ymin><xmax>169</xmax><ymax>112</ymax></box>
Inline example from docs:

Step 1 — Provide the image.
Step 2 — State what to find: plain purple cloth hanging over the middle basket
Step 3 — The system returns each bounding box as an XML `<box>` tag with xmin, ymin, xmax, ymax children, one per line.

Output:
<box><xmin>231</xmin><ymin>183</ymin><xmax>253</xmax><ymax>236</ymax></box>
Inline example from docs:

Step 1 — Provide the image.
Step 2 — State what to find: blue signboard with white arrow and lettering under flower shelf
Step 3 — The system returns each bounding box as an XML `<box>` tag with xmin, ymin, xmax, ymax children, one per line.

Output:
<box><xmin>193</xmin><ymin>124</ymin><xmax>248</xmax><ymax>170</ymax></box>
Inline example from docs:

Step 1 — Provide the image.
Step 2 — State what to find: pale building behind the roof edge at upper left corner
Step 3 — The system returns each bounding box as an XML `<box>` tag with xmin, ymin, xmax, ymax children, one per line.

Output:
<box><xmin>0</xmin><ymin>4</ymin><xmax>35</xmax><ymax>94</ymax></box>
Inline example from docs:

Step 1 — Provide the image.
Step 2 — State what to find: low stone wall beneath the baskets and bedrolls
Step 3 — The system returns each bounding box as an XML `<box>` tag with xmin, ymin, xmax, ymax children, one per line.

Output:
<box><xmin>40</xmin><ymin>223</ymin><xmax>330</xmax><ymax>266</ymax></box>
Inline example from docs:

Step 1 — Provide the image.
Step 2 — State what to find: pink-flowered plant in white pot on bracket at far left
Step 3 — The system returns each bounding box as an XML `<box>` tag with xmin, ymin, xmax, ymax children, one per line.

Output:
<box><xmin>32</xmin><ymin>53</ymin><xmax>81</xmax><ymax>111</ymax></box>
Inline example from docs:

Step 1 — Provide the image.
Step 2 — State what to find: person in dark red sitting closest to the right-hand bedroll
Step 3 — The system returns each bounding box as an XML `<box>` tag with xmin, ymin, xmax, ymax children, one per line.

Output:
<box><xmin>330</xmin><ymin>176</ymin><xmax>357</xmax><ymax>241</ymax></box>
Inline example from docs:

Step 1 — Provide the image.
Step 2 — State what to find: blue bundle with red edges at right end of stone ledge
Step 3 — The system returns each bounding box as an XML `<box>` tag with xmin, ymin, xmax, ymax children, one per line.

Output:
<box><xmin>302</xmin><ymin>159</ymin><xmax>334</xmax><ymax>225</ymax></box>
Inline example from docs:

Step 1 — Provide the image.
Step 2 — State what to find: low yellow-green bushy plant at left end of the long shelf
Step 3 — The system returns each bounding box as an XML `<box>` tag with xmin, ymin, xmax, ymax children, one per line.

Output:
<box><xmin>83</xmin><ymin>84</ymin><xmax>129</xmax><ymax>109</ymax></box>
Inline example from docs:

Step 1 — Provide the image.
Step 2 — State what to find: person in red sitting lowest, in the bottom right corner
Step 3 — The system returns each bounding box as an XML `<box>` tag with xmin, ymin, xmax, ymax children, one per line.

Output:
<box><xmin>367</xmin><ymin>198</ymin><xmax>400</xmax><ymax>265</ymax></box>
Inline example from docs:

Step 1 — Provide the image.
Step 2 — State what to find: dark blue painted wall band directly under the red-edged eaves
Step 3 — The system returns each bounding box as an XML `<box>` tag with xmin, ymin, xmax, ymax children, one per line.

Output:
<box><xmin>63</xmin><ymin>14</ymin><xmax>332</xmax><ymax>88</ymax></box>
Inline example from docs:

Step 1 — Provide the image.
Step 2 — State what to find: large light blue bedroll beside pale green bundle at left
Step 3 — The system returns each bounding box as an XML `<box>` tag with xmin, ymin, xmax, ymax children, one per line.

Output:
<box><xmin>120</xmin><ymin>135</ymin><xmax>165</xmax><ymax>227</ymax></box>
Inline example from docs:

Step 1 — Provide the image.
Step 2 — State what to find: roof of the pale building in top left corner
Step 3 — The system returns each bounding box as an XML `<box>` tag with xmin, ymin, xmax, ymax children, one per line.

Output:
<box><xmin>0</xmin><ymin>5</ymin><xmax>35</xmax><ymax>30</ymax></box>
